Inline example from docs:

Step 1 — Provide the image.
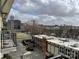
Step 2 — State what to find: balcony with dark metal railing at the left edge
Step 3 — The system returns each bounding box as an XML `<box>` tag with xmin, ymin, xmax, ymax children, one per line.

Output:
<box><xmin>1</xmin><ymin>30</ymin><xmax>17</xmax><ymax>49</ymax></box>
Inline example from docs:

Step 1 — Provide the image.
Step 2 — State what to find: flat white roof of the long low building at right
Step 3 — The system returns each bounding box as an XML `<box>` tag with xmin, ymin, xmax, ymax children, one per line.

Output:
<box><xmin>35</xmin><ymin>35</ymin><xmax>79</xmax><ymax>51</ymax></box>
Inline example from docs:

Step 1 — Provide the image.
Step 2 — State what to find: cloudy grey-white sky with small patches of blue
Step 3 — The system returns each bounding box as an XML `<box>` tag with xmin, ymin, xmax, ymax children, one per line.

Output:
<box><xmin>9</xmin><ymin>0</ymin><xmax>79</xmax><ymax>26</ymax></box>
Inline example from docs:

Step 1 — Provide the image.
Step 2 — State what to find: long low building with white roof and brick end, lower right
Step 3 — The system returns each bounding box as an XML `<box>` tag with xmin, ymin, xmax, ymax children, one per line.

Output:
<box><xmin>33</xmin><ymin>35</ymin><xmax>79</xmax><ymax>59</ymax></box>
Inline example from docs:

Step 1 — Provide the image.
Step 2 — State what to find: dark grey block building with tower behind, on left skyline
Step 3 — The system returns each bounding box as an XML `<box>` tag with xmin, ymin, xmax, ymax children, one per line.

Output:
<box><xmin>7</xmin><ymin>16</ymin><xmax>21</xmax><ymax>31</ymax></box>
